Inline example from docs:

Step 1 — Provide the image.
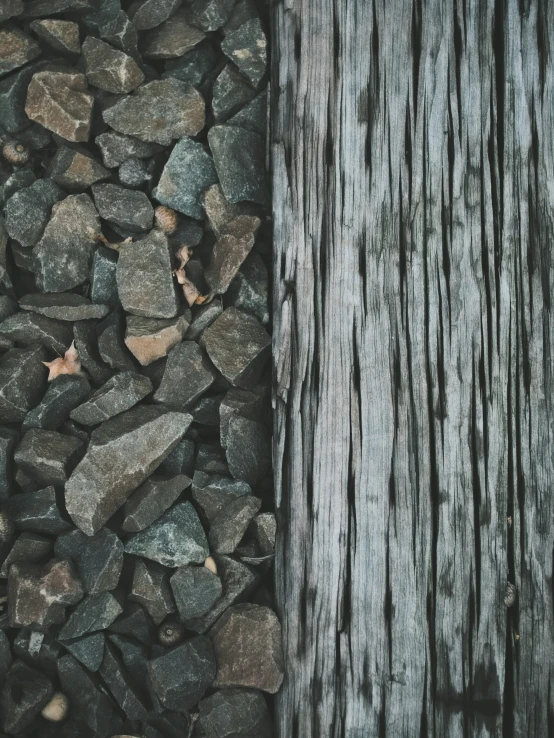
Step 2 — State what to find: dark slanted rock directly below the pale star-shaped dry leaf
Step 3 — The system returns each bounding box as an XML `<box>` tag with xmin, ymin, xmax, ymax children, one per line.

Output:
<box><xmin>23</xmin><ymin>374</ymin><xmax>90</xmax><ymax>431</ymax></box>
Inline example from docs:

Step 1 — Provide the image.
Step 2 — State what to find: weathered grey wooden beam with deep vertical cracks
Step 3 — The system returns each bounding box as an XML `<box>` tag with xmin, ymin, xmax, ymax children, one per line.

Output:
<box><xmin>271</xmin><ymin>0</ymin><xmax>554</xmax><ymax>738</ymax></box>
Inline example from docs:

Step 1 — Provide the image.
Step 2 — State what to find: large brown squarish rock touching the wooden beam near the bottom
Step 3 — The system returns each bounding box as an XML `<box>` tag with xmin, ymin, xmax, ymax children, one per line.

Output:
<box><xmin>210</xmin><ymin>603</ymin><xmax>284</xmax><ymax>694</ymax></box>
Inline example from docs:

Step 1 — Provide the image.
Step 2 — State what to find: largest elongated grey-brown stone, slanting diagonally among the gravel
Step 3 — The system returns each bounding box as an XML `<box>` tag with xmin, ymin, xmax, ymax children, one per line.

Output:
<box><xmin>65</xmin><ymin>407</ymin><xmax>191</xmax><ymax>540</ymax></box>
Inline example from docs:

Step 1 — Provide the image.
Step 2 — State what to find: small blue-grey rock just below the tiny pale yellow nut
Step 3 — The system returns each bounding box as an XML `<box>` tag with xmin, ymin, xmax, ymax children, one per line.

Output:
<box><xmin>170</xmin><ymin>566</ymin><xmax>223</xmax><ymax>623</ymax></box>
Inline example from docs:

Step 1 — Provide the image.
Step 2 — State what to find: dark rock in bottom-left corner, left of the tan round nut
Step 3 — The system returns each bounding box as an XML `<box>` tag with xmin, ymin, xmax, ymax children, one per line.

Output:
<box><xmin>0</xmin><ymin>661</ymin><xmax>54</xmax><ymax>734</ymax></box>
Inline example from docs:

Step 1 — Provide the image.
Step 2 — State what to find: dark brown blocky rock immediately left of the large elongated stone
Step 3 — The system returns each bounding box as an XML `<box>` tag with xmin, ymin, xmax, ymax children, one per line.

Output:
<box><xmin>14</xmin><ymin>428</ymin><xmax>83</xmax><ymax>484</ymax></box>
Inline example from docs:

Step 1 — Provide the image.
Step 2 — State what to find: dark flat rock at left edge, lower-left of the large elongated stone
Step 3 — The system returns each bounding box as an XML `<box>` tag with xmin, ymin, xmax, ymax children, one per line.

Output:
<box><xmin>6</xmin><ymin>487</ymin><xmax>71</xmax><ymax>535</ymax></box>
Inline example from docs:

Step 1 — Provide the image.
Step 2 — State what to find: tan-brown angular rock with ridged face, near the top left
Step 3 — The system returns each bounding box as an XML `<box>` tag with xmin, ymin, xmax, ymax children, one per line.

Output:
<box><xmin>25</xmin><ymin>69</ymin><xmax>94</xmax><ymax>141</ymax></box>
